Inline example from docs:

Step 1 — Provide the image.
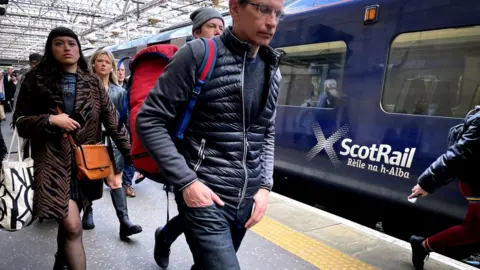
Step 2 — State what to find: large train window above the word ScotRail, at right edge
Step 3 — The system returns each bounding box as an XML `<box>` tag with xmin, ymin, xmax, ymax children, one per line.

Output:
<box><xmin>381</xmin><ymin>26</ymin><xmax>480</xmax><ymax>118</ymax></box>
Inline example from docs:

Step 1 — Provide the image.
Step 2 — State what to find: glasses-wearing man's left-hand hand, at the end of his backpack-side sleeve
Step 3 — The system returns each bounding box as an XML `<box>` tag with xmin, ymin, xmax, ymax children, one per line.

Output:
<box><xmin>182</xmin><ymin>180</ymin><xmax>224</xmax><ymax>208</ymax></box>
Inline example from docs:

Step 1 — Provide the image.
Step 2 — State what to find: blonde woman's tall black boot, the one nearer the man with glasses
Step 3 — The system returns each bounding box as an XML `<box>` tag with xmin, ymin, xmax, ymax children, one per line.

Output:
<box><xmin>110</xmin><ymin>187</ymin><xmax>143</xmax><ymax>240</ymax></box>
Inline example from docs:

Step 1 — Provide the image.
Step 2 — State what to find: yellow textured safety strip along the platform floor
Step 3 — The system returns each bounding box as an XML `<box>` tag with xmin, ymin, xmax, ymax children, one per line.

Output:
<box><xmin>252</xmin><ymin>216</ymin><xmax>376</xmax><ymax>270</ymax></box>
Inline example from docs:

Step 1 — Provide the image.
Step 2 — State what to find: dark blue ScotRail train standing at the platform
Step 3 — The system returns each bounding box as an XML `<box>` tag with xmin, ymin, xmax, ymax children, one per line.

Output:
<box><xmin>86</xmin><ymin>0</ymin><xmax>480</xmax><ymax>243</ymax></box>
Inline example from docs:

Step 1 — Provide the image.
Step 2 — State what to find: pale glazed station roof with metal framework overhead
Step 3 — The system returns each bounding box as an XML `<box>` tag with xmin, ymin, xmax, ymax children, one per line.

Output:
<box><xmin>0</xmin><ymin>0</ymin><xmax>228</xmax><ymax>60</ymax></box>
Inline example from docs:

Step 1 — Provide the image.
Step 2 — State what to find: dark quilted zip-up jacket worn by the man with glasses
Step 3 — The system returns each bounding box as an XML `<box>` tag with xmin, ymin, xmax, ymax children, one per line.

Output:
<box><xmin>136</xmin><ymin>29</ymin><xmax>281</xmax><ymax>207</ymax></box>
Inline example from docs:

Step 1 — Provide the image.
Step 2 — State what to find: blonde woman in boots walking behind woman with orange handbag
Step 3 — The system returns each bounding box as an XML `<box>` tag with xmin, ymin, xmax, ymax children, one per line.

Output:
<box><xmin>82</xmin><ymin>50</ymin><xmax>142</xmax><ymax>240</ymax></box>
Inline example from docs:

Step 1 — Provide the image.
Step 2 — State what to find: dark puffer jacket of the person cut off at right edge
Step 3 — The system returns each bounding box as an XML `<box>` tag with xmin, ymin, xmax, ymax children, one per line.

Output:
<box><xmin>418</xmin><ymin>110</ymin><xmax>480</xmax><ymax>196</ymax></box>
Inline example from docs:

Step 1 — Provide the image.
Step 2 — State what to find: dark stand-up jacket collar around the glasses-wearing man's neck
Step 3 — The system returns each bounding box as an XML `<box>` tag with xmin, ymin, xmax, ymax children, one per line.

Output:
<box><xmin>220</xmin><ymin>26</ymin><xmax>282</xmax><ymax>66</ymax></box>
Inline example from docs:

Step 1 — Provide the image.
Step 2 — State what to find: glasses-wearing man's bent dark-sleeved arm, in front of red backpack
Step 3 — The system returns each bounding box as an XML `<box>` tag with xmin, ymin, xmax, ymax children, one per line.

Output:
<box><xmin>136</xmin><ymin>40</ymin><xmax>205</xmax><ymax>189</ymax></box>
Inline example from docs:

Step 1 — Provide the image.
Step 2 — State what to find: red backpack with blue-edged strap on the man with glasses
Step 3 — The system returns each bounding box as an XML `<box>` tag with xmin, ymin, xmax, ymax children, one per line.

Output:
<box><xmin>127</xmin><ymin>38</ymin><xmax>217</xmax><ymax>184</ymax></box>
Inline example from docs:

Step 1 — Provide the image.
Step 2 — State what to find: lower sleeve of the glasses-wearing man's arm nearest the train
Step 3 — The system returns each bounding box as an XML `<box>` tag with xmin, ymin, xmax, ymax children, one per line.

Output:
<box><xmin>260</xmin><ymin>110</ymin><xmax>277</xmax><ymax>191</ymax></box>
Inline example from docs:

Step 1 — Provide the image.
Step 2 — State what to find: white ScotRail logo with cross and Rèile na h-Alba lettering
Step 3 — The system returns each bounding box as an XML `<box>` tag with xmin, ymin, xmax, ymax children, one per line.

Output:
<box><xmin>307</xmin><ymin>122</ymin><xmax>416</xmax><ymax>179</ymax></box>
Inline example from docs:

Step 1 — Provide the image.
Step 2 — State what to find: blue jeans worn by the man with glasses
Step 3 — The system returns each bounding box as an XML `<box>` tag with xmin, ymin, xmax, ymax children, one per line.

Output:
<box><xmin>176</xmin><ymin>196</ymin><xmax>253</xmax><ymax>270</ymax></box>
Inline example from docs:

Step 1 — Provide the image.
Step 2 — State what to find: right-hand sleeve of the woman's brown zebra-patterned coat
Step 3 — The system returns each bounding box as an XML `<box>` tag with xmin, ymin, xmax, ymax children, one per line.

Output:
<box><xmin>98</xmin><ymin>85</ymin><xmax>131</xmax><ymax>162</ymax></box>
